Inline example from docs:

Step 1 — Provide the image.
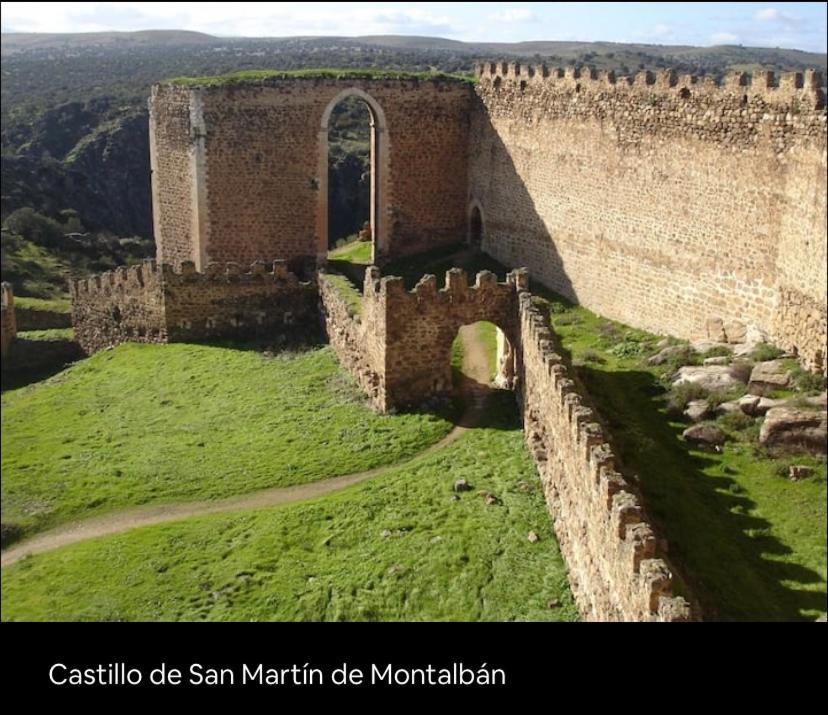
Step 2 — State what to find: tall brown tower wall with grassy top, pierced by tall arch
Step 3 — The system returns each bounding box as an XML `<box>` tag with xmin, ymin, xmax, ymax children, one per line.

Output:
<box><xmin>150</xmin><ymin>77</ymin><xmax>473</xmax><ymax>269</ymax></box>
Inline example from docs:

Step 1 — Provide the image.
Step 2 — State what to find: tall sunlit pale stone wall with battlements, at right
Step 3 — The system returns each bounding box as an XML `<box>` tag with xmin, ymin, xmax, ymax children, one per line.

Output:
<box><xmin>469</xmin><ymin>64</ymin><xmax>826</xmax><ymax>370</ymax></box>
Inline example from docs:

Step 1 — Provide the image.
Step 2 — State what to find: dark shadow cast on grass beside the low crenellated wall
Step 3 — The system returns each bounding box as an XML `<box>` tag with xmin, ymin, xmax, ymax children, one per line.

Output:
<box><xmin>577</xmin><ymin>366</ymin><xmax>826</xmax><ymax>621</ymax></box>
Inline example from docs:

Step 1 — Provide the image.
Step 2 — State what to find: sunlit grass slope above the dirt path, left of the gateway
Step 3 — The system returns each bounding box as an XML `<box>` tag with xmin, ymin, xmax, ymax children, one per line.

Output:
<box><xmin>2</xmin><ymin>343</ymin><xmax>460</xmax><ymax>532</ymax></box>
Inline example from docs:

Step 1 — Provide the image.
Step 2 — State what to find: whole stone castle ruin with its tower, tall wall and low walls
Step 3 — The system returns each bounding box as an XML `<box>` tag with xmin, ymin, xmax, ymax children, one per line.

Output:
<box><xmin>72</xmin><ymin>63</ymin><xmax>826</xmax><ymax>620</ymax></box>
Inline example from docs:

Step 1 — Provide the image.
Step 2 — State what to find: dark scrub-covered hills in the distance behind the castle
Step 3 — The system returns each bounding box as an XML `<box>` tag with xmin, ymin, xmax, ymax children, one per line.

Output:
<box><xmin>0</xmin><ymin>30</ymin><xmax>826</xmax><ymax>297</ymax></box>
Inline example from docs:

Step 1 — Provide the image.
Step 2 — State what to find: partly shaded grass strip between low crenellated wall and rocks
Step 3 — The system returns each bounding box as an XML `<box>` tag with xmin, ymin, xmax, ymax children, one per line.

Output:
<box><xmin>547</xmin><ymin>295</ymin><xmax>828</xmax><ymax>620</ymax></box>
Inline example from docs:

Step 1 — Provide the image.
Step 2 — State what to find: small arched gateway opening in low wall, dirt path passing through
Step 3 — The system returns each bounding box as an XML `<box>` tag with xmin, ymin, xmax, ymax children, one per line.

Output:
<box><xmin>451</xmin><ymin>320</ymin><xmax>516</xmax><ymax>394</ymax></box>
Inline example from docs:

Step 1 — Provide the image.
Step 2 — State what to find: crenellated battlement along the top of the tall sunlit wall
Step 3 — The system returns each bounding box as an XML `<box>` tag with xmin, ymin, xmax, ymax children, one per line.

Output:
<box><xmin>475</xmin><ymin>62</ymin><xmax>825</xmax><ymax>109</ymax></box>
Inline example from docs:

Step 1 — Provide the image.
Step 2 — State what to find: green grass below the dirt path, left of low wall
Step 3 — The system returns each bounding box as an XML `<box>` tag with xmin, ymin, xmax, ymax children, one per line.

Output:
<box><xmin>2</xmin><ymin>393</ymin><xmax>577</xmax><ymax>621</ymax></box>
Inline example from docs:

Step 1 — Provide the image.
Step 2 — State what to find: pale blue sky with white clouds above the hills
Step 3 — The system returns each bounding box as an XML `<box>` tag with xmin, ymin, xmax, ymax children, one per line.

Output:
<box><xmin>0</xmin><ymin>2</ymin><xmax>826</xmax><ymax>52</ymax></box>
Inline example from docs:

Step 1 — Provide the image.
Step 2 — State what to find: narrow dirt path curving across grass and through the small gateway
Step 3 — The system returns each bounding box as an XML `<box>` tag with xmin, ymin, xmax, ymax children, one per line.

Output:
<box><xmin>2</xmin><ymin>326</ymin><xmax>489</xmax><ymax>566</ymax></box>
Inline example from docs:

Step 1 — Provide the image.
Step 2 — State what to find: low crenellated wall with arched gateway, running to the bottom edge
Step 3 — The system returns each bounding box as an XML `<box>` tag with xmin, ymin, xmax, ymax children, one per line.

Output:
<box><xmin>319</xmin><ymin>267</ymin><xmax>690</xmax><ymax>621</ymax></box>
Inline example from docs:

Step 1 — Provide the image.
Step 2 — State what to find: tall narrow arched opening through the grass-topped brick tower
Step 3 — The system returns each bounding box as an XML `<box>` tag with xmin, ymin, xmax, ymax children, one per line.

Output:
<box><xmin>326</xmin><ymin>88</ymin><xmax>385</xmax><ymax>264</ymax></box>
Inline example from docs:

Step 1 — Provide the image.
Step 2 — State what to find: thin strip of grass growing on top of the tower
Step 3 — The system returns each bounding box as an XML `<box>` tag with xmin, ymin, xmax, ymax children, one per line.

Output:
<box><xmin>167</xmin><ymin>68</ymin><xmax>477</xmax><ymax>87</ymax></box>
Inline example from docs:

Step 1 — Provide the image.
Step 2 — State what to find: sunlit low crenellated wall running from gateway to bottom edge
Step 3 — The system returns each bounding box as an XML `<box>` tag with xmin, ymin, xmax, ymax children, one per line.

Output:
<box><xmin>517</xmin><ymin>292</ymin><xmax>690</xmax><ymax>621</ymax></box>
